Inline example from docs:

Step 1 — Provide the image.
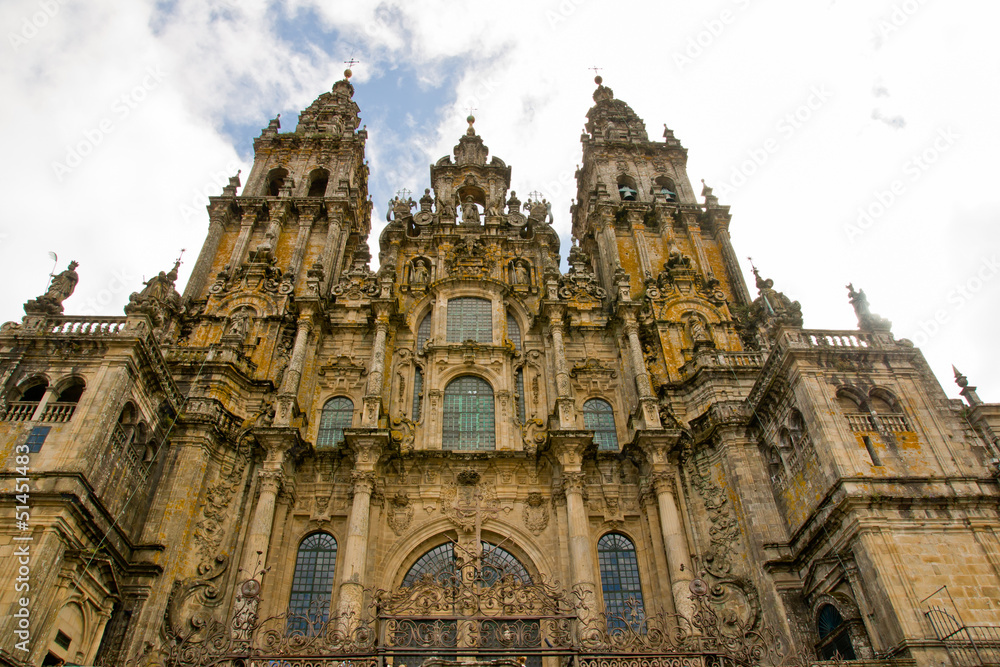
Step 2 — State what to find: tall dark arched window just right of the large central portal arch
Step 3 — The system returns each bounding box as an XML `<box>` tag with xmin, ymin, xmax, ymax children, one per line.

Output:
<box><xmin>597</xmin><ymin>533</ymin><xmax>644</xmax><ymax>629</ymax></box>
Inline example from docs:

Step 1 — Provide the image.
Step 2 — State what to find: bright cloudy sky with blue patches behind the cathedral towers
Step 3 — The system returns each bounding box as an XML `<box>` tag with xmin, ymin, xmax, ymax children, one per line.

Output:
<box><xmin>0</xmin><ymin>0</ymin><xmax>1000</xmax><ymax>401</ymax></box>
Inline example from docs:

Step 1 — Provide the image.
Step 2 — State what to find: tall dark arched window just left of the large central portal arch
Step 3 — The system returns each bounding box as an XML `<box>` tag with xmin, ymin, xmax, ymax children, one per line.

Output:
<box><xmin>288</xmin><ymin>533</ymin><xmax>337</xmax><ymax>634</ymax></box>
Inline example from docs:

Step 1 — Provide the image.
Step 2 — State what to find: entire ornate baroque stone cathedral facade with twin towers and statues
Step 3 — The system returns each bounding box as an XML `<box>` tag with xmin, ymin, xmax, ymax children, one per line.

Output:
<box><xmin>0</xmin><ymin>73</ymin><xmax>1000</xmax><ymax>667</ymax></box>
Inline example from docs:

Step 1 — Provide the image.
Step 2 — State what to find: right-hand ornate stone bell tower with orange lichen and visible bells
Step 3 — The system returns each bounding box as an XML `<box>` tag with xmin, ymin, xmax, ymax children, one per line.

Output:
<box><xmin>573</xmin><ymin>77</ymin><xmax>750</xmax><ymax>390</ymax></box>
